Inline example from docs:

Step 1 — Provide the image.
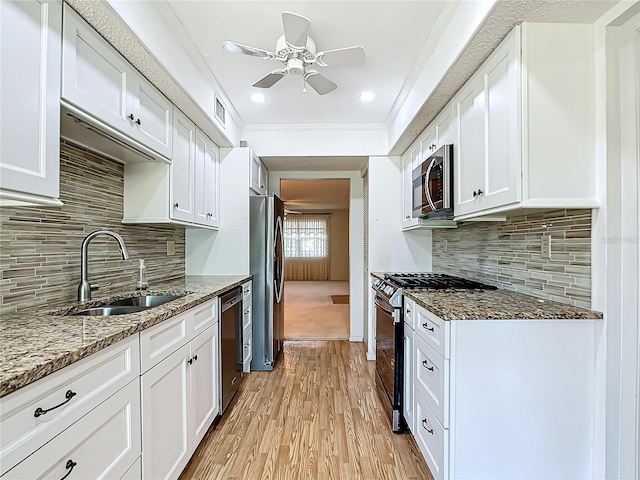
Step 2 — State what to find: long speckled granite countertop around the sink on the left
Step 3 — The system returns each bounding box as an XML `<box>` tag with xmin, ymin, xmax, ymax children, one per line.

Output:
<box><xmin>0</xmin><ymin>275</ymin><xmax>252</xmax><ymax>397</ymax></box>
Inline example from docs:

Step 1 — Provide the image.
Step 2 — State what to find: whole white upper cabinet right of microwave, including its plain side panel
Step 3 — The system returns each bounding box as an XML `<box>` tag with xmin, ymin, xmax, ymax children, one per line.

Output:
<box><xmin>453</xmin><ymin>23</ymin><xmax>598</xmax><ymax>220</ymax></box>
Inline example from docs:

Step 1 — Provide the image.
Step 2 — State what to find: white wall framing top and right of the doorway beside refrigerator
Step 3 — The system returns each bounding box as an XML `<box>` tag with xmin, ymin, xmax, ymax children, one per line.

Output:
<box><xmin>269</xmin><ymin>169</ymin><xmax>368</xmax><ymax>342</ymax></box>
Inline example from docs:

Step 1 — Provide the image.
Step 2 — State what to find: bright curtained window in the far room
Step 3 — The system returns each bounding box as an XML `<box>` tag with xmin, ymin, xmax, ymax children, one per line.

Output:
<box><xmin>284</xmin><ymin>214</ymin><xmax>329</xmax><ymax>258</ymax></box>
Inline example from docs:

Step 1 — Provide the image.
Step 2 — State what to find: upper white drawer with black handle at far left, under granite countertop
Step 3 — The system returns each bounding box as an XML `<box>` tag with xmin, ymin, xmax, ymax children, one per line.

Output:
<box><xmin>0</xmin><ymin>335</ymin><xmax>140</xmax><ymax>475</ymax></box>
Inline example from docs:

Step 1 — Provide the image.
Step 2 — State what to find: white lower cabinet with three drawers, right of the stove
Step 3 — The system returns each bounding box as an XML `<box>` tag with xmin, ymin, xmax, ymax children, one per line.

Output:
<box><xmin>405</xmin><ymin>302</ymin><xmax>599</xmax><ymax>480</ymax></box>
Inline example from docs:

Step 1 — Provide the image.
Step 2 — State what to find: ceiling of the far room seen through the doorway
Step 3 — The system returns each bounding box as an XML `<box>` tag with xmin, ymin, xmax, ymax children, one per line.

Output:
<box><xmin>280</xmin><ymin>179</ymin><xmax>350</xmax><ymax>211</ymax></box>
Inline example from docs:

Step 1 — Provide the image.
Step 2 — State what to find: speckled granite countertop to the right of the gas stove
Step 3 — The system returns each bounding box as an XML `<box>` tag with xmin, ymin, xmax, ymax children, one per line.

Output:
<box><xmin>403</xmin><ymin>289</ymin><xmax>602</xmax><ymax>320</ymax></box>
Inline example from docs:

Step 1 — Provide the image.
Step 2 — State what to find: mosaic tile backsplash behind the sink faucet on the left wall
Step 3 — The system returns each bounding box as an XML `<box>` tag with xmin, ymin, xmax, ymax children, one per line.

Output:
<box><xmin>0</xmin><ymin>142</ymin><xmax>185</xmax><ymax>314</ymax></box>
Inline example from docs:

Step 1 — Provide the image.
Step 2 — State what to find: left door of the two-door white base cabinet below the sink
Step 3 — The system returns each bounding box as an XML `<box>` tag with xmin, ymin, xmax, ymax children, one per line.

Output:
<box><xmin>141</xmin><ymin>344</ymin><xmax>191</xmax><ymax>480</ymax></box>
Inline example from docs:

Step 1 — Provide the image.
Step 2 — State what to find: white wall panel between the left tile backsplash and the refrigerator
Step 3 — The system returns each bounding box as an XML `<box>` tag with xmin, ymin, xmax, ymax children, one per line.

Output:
<box><xmin>185</xmin><ymin>147</ymin><xmax>251</xmax><ymax>275</ymax></box>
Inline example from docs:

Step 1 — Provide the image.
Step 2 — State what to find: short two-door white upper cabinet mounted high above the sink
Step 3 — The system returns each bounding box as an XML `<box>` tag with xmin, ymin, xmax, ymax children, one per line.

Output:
<box><xmin>62</xmin><ymin>5</ymin><xmax>173</xmax><ymax>159</ymax></box>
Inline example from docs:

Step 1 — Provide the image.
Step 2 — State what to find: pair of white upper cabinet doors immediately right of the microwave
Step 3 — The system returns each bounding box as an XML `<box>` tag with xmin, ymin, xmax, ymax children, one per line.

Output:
<box><xmin>453</xmin><ymin>28</ymin><xmax>521</xmax><ymax>215</ymax></box>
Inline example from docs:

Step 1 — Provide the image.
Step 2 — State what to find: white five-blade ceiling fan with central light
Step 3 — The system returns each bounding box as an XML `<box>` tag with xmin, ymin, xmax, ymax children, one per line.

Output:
<box><xmin>222</xmin><ymin>12</ymin><xmax>367</xmax><ymax>95</ymax></box>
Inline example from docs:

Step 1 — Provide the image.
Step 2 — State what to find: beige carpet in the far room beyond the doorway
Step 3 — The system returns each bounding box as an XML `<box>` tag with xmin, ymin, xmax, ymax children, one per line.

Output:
<box><xmin>284</xmin><ymin>281</ymin><xmax>349</xmax><ymax>340</ymax></box>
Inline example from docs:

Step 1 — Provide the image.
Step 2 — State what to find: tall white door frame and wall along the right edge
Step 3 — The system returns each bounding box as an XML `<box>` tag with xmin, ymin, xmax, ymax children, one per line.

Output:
<box><xmin>591</xmin><ymin>0</ymin><xmax>640</xmax><ymax>479</ymax></box>
